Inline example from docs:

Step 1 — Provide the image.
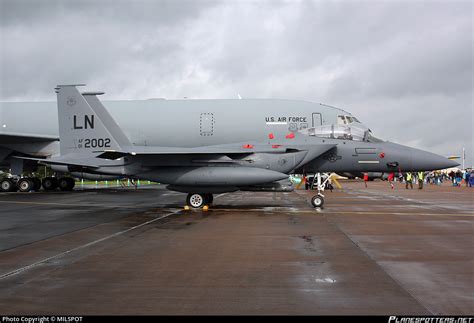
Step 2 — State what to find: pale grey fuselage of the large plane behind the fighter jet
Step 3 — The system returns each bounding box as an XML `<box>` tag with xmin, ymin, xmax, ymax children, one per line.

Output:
<box><xmin>0</xmin><ymin>99</ymin><xmax>352</xmax><ymax>147</ymax></box>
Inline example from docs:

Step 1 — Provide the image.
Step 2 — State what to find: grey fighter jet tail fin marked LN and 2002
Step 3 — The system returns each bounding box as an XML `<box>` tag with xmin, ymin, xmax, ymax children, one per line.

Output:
<box><xmin>56</xmin><ymin>85</ymin><xmax>131</xmax><ymax>155</ymax></box>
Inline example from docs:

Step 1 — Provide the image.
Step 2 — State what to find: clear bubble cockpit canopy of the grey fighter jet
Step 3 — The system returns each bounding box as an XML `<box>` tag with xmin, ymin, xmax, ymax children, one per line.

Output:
<box><xmin>301</xmin><ymin>124</ymin><xmax>384</xmax><ymax>142</ymax></box>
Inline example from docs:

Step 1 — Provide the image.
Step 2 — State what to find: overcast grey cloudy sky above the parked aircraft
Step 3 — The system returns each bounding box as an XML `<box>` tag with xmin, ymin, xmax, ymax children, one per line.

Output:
<box><xmin>0</xmin><ymin>0</ymin><xmax>474</xmax><ymax>167</ymax></box>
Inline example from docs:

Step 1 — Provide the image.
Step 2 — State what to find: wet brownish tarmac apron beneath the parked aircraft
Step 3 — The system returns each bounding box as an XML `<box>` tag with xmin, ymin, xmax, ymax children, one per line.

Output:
<box><xmin>0</xmin><ymin>182</ymin><xmax>474</xmax><ymax>315</ymax></box>
